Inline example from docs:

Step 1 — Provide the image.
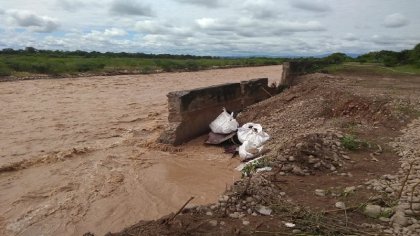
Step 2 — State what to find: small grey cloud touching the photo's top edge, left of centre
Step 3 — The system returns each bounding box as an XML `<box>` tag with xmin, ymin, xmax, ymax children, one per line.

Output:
<box><xmin>110</xmin><ymin>0</ymin><xmax>153</xmax><ymax>16</ymax></box>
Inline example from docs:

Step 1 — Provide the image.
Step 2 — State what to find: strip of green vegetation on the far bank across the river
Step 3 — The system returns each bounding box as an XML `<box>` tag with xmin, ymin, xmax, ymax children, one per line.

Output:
<box><xmin>0</xmin><ymin>48</ymin><xmax>283</xmax><ymax>77</ymax></box>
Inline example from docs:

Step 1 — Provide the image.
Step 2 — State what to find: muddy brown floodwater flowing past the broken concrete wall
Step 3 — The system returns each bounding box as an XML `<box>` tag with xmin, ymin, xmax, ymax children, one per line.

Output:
<box><xmin>0</xmin><ymin>66</ymin><xmax>282</xmax><ymax>235</ymax></box>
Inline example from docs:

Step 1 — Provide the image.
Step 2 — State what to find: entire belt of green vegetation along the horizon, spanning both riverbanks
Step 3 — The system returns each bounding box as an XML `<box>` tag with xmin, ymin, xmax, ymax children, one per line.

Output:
<box><xmin>0</xmin><ymin>44</ymin><xmax>420</xmax><ymax>77</ymax></box>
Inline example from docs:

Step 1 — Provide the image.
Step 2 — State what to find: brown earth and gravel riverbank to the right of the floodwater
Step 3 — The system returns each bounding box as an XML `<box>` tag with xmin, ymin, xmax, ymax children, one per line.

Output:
<box><xmin>108</xmin><ymin>74</ymin><xmax>420</xmax><ymax>235</ymax></box>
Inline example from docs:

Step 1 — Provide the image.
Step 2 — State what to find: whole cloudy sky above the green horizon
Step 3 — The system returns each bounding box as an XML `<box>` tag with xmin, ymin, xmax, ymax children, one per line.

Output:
<box><xmin>0</xmin><ymin>0</ymin><xmax>420</xmax><ymax>56</ymax></box>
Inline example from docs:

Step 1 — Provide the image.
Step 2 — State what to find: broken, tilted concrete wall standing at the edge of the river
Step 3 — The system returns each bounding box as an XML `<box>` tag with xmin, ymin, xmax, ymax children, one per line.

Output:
<box><xmin>159</xmin><ymin>63</ymin><xmax>292</xmax><ymax>145</ymax></box>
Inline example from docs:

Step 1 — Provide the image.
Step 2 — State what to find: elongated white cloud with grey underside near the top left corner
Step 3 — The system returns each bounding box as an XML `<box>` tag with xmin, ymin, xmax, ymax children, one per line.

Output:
<box><xmin>6</xmin><ymin>10</ymin><xmax>60</xmax><ymax>33</ymax></box>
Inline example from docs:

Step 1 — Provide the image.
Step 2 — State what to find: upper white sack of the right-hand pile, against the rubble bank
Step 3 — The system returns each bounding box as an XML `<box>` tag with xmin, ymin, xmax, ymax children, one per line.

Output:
<box><xmin>238</xmin><ymin>123</ymin><xmax>270</xmax><ymax>147</ymax></box>
